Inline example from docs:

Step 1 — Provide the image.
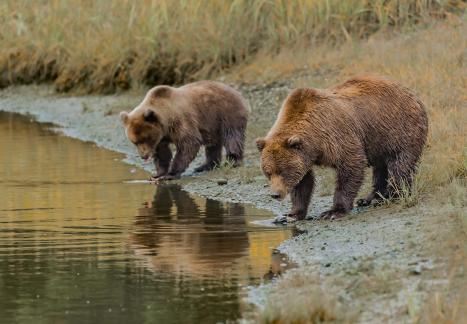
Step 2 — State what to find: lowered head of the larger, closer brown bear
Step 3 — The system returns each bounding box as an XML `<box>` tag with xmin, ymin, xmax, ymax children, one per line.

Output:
<box><xmin>256</xmin><ymin>135</ymin><xmax>309</xmax><ymax>200</ymax></box>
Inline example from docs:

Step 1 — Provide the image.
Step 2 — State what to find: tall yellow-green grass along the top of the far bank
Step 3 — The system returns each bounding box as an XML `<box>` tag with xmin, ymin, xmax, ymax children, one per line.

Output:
<box><xmin>0</xmin><ymin>0</ymin><xmax>465</xmax><ymax>93</ymax></box>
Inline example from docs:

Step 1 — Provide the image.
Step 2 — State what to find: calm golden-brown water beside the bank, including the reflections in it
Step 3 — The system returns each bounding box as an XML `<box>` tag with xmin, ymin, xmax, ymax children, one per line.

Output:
<box><xmin>0</xmin><ymin>112</ymin><xmax>291</xmax><ymax>323</ymax></box>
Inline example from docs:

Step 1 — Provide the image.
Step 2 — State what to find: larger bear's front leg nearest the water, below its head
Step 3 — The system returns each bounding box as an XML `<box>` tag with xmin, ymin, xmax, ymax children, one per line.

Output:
<box><xmin>286</xmin><ymin>171</ymin><xmax>315</xmax><ymax>220</ymax></box>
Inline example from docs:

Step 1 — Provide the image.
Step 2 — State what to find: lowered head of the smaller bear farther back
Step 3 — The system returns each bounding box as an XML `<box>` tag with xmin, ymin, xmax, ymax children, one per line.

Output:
<box><xmin>120</xmin><ymin>108</ymin><xmax>164</xmax><ymax>160</ymax></box>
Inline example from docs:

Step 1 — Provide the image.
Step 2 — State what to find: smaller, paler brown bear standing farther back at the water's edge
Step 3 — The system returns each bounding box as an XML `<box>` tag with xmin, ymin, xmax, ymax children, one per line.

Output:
<box><xmin>120</xmin><ymin>81</ymin><xmax>248</xmax><ymax>180</ymax></box>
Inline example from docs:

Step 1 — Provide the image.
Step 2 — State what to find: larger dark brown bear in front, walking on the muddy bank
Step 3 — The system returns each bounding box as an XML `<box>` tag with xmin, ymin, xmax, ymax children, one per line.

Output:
<box><xmin>257</xmin><ymin>75</ymin><xmax>428</xmax><ymax>219</ymax></box>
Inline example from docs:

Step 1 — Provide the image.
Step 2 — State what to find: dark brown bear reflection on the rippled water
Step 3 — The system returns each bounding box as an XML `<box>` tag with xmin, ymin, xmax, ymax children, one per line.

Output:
<box><xmin>131</xmin><ymin>184</ymin><xmax>292</xmax><ymax>277</ymax></box>
